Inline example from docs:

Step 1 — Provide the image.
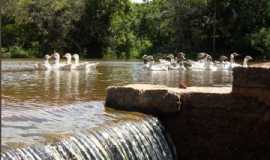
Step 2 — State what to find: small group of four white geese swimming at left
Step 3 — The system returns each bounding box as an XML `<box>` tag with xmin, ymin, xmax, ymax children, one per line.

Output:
<box><xmin>35</xmin><ymin>52</ymin><xmax>98</xmax><ymax>70</ymax></box>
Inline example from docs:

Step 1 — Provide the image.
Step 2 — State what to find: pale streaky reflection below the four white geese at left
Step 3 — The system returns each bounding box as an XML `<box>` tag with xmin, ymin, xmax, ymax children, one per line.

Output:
<box><xmin>41</xmin><ymin>70</ymin><xmax>95</xmax><ymax>101</ymax></box>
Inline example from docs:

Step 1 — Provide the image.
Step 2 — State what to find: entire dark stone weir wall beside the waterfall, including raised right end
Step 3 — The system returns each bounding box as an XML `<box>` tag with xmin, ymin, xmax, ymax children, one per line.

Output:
<box><xmin>105</xmin><ymin>68</ymin><xmax>270</xmax><ymax>160</ymax></box>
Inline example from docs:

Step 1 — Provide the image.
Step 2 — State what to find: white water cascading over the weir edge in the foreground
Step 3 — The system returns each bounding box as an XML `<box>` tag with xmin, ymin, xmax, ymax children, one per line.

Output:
<box><xmin>1</xmin><ymin>116</ymin><xmax>176</xmax><ymax>160</ymax></box>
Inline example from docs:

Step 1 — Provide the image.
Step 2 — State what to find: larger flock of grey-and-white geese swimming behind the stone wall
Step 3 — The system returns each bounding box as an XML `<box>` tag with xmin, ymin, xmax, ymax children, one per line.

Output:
<box><xmin>142</xmin><ymin>52</ymin><xmax>252</xmax><ymax>71</ymax></box>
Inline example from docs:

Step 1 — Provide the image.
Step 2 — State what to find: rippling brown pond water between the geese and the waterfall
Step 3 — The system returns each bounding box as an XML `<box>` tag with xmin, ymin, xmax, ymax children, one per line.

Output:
<box><xmin>1</xmin><ymin>60</ymin><xmax>232</xmax><ymax>152</ymax></box>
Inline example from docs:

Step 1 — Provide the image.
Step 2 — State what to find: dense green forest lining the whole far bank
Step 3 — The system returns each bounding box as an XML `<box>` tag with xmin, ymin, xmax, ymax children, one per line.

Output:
<box><xmin>1</xmin><ymin>0</ymin><xmax>270</xmax><ymax>58</ymax></box>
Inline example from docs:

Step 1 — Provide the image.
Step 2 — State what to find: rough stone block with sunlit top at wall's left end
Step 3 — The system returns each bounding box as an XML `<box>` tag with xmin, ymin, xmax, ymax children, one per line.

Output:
<box><xmin>105</xmin><ymin>84</ymin><xmax>181</xmax><ymax>114</ymax></box>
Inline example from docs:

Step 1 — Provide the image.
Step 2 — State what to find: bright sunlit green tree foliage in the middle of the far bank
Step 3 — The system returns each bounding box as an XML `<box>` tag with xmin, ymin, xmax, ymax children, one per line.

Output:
<box><xmin>108</xmin><ymin>2</ymin><xmax>152</xmax><ymax>58</ymax></box>
